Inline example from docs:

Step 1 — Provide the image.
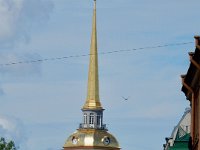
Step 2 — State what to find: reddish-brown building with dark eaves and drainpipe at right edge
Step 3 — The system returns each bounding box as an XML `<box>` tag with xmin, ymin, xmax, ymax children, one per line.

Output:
<box><xmin>181</xmin><ymin>36</ymin><xmax>200</xmax><ymax>150</ymax></box>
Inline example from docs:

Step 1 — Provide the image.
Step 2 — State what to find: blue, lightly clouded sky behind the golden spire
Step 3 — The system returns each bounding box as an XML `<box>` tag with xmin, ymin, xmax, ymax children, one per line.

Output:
<box><xmin>0</xmin><ymin>0</ymin><xmax>200</xmax><ymax>150</ymax></box>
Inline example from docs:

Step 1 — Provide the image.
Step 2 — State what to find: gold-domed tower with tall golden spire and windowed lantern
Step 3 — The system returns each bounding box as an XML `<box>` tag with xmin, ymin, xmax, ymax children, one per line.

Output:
<box><xmin>63</xmin><ymin>0</ymin><xmax>120</xmax><ymax>150</ymax></box>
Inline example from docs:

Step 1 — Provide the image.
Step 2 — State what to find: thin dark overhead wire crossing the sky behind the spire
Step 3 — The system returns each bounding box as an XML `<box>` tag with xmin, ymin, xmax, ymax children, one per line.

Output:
<box><xmin>0</xmin><ymin>42</ymin><xmax>193</xmax><ymax>67</ymax></box>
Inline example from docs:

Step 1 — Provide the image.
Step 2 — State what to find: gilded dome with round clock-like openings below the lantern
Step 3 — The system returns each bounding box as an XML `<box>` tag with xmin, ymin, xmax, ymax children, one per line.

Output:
<box><xmin>64</xmin><ymin>129</ymin><xmax>120</xmax><ymax>150</ymax></box>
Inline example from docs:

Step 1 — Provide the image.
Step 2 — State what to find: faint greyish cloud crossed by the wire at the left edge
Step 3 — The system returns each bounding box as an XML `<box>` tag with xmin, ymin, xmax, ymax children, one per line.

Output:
<box><xmin>0</xmin><ymin>52</ymin><xmax>42</xmax><ymax>96</ymax></box>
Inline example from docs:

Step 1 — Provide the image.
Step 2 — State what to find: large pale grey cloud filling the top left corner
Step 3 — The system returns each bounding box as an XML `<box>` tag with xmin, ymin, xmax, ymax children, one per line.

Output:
<box><xmin>0</xmin><ymin>0</ymin><xmax>53</xmax><ymax>48</ymax></box>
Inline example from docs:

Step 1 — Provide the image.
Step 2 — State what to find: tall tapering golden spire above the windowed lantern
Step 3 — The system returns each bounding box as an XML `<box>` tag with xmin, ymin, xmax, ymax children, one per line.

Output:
<box><xmin>83</xmin><ymin>0</ymin><xmax>102</xmax><ymax>109</ymax></box>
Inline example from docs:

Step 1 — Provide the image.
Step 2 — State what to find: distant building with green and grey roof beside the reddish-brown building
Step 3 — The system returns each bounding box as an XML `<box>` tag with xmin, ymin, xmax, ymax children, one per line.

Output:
<box><xmin>163</xmin><ymin>108</ymin><xmax>191</xmax><ymax>150</ymax></box>
